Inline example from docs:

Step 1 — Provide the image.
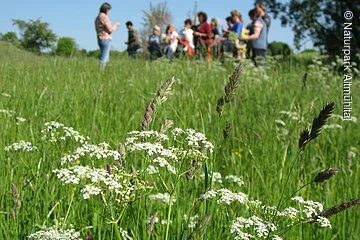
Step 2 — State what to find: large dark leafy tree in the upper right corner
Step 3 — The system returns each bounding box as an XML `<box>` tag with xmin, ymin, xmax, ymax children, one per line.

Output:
<box><xmin>264</xmin><ymin>0</ymin><xmax>360</xmax><ymax>54</ymax></box>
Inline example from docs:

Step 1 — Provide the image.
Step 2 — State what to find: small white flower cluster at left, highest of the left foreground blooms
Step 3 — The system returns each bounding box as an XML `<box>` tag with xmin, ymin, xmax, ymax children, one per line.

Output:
<box><xmin>41</xmin><ymin>121</ymin><xmax>89</xmax><ymax>144</ymax></box>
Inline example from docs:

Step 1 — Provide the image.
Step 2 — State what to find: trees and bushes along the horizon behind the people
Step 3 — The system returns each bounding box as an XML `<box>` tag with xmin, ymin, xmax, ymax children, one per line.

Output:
<box><xmin>0</xmin><ymin>0</ymin><xmax>360</xmax><ymax>56</ymax></box>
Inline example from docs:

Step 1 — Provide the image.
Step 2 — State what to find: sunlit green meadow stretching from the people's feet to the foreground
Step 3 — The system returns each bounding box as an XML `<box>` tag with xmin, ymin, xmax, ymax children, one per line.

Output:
<box><xmin>0</xmin><ymin>42</ymin><xmax>360</xmax><ymax>240</ymax></box>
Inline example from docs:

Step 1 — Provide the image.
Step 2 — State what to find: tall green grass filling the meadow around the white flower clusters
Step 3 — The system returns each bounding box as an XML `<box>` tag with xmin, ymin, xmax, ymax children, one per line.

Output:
<box><xmin>0</xmin><ymin>42</ymin><xmax>360</xmax><ymax>239</ymax></box>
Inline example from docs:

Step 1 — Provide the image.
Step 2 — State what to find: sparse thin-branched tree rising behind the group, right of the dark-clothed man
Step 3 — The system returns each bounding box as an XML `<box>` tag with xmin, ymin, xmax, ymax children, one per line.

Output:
<box><xmin>140</xmin><ymin>2</ymin><xmax>173</xmax><ymax>46</ymax></box>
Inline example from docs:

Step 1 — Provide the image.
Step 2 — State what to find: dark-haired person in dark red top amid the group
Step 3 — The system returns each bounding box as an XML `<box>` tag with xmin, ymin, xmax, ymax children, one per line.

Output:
<box><xmin>194</xmin><ymin>12</ymin><xmax>211</xmax><ymax>61</ymax></box>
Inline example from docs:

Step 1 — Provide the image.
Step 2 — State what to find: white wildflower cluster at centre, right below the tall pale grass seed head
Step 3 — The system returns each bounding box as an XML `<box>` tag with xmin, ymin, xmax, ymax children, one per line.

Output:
<box><xmin>125</xmin><ymin>128</ymin><xmax>214</xmax><ymax>174</ymax></box>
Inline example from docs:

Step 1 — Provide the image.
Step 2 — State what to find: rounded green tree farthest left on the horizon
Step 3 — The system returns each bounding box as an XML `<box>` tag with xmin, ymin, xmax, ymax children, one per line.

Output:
<box><xmin>12</xmin><ymin>19</ymin><xmax>57</xmax><ymax>53</ymax></box>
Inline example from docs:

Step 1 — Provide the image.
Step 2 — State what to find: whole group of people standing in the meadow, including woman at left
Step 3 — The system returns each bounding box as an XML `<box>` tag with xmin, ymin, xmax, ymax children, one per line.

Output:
<box><xmin>95</xmin><ymin>3</ymin><xmax>270</xmax><ymax>68</ymax></box>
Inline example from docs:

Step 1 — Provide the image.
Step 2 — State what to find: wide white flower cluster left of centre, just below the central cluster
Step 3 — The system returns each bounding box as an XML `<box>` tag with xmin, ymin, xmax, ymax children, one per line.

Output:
<box><xmin>53</xmin><ymin>166</ymin><xmax>150</xmax><ymax>205</ymax></box>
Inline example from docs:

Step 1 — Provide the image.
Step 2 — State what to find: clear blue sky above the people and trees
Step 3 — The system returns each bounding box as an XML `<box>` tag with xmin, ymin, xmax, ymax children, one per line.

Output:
<box><xmin>0</xmin><ymin>0</ymin><xmax>312</xmax><ymax>50</ymax></box>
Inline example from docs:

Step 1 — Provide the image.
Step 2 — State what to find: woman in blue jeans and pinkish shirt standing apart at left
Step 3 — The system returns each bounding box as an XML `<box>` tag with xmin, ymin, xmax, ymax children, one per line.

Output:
<box><xmin>95</xmin><ymin>2</ymin><xmax>120</xmax><ymax>69</ymax></box>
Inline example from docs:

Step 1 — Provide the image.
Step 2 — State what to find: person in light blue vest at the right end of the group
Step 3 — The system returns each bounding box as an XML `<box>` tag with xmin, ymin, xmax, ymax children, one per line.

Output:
<box><xmin>240</xmin><ymin>8</ymin><xmax>267</xmax><ymax>67</ymax></box>
